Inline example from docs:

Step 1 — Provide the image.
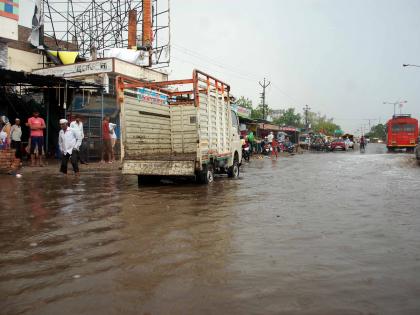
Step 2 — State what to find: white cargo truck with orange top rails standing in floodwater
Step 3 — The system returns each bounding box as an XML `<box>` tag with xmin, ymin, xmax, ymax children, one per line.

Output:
<box><xmin>116</xmin><ymin>70</ymin><xmax>242</xmax><ymax>184</ymax></box>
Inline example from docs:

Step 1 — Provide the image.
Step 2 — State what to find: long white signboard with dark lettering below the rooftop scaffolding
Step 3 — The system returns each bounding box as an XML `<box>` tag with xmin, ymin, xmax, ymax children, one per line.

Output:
<box><xmin>33</xmin><ymin>59</ymin><xmax>113</xmax><ymax>78</ymax></box>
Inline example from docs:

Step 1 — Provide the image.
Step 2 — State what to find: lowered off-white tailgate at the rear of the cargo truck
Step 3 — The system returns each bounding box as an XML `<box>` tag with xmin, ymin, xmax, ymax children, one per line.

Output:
<box><xmin>122</xmin><ymin>160</ymin><xmax>195</xmax><ymax>176</ymax></box>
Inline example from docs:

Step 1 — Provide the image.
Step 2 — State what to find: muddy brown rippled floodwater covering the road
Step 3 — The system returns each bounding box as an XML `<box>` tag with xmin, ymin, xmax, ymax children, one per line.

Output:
<box><xmin>0</xmin><ymin>145</ymin><xmax>420</xmax><ymax>315</ymax></box>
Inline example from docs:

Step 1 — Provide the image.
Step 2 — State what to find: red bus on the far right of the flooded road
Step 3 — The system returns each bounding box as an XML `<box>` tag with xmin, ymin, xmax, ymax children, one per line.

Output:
<box><xmin>386</xmin><ymin>115</ymin><xmax>419</xmax><ymax>152</ymax></box>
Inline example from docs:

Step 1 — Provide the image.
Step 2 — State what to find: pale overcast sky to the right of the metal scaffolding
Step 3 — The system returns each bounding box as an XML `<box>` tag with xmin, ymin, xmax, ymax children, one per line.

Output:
<box><xmin>171</xmin><ymin>0</ymin><xmax>420</xmax><ymax>131</ymax></box>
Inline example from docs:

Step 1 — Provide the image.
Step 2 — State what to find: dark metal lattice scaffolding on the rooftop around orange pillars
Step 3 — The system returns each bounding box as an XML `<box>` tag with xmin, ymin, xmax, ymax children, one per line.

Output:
<box><xmin>42</xmin><ymin>0</ymin><xmax>170</xmax><ymax>68</ymax></box>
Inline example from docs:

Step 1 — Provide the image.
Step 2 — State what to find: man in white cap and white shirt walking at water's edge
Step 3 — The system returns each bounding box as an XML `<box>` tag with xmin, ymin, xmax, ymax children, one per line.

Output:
<box><xmin>58</xmin><ymin>119</ymin><xmax>82</xmax><ymax>175</ymax></box>
